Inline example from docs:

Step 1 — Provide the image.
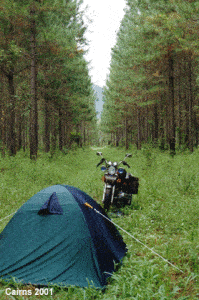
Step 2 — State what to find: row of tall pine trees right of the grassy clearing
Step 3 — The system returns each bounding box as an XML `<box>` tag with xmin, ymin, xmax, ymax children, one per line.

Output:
<box><xmin>101</xmin><ymin>0</ymin><xmax>199</xmax><ymax>153</ymax></box>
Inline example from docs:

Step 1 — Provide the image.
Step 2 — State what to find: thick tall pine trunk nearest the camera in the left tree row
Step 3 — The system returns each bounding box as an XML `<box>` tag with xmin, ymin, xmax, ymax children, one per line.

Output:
<box><xmin>30</xmin><ymin>7</ymin><xmax>38</xmax><ymax>159</ymax></box>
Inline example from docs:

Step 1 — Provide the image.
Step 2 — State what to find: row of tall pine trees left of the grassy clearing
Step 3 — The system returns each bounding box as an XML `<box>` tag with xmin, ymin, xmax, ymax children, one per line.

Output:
<box><xmin>0</xmin><ymin>0</ymin><xmax>96</xmax><ymax>158</ymax></box>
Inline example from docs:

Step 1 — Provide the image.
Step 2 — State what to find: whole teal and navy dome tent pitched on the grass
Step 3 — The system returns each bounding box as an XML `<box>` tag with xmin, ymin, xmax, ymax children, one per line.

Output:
<box><xmin>0</xmin><ymin>185</ymin><xmax>127</xmax><ymax>288</ymax></box>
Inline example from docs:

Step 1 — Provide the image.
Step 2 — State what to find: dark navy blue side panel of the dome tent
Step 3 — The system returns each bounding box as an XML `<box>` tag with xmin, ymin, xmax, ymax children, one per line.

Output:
<box><xmin>63</xmin><ymin>186</ymin><xmax>126</xmax><ymax>277</ymax></box>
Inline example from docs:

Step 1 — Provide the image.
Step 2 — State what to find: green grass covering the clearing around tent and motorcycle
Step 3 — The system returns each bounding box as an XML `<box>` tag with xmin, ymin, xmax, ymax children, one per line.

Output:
<box><xmin>0</xmin><ymin>147</ymin><xmax>199</xmax><ymax>300</ymax></box>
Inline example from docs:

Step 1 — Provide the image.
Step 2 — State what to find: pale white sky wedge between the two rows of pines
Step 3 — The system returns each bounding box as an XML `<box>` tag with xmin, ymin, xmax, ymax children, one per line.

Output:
<box><xmin>82</xmin><ymin>0</ymin><xmax>126</xmax><ymax>87</ymax></box>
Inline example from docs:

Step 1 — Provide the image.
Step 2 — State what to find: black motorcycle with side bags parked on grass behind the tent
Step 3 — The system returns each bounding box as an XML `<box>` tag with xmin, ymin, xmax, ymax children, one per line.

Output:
<box><xmin>96</xmin><ymin>152</ymin><xmax>139</xmax><ymax>211</ymax></box>
